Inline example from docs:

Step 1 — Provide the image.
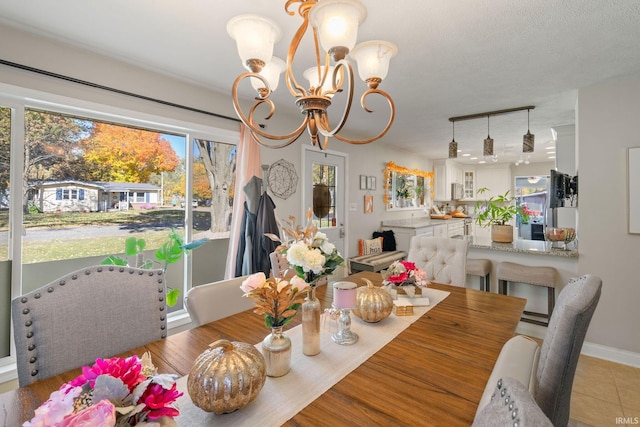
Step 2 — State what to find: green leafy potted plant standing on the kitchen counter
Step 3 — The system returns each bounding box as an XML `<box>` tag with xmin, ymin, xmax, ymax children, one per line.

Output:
<box><xmin>475</xmin><ymin>187</ymin><xmax>529</xmax><ymax>243</ymax></box>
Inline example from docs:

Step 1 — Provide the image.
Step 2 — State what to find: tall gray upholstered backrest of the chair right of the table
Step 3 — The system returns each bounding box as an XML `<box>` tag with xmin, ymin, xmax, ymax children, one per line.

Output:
<box><xmin>533</xmin><ymin>274</ymin><xmax>602</xmax><ymax>426</ymax></box>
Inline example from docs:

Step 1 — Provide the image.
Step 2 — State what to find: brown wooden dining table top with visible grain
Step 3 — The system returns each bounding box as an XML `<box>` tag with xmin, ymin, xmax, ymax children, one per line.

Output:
<box><xmin>0</xmin><ymin>272</ymin><xmax>526</xmax><ymax>427</ymax></box>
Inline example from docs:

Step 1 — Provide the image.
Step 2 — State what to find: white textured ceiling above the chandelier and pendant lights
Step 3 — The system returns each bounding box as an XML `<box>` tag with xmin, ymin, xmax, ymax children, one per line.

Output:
<box><xmin>0</xmin><ymin>0</ymin><xmax>640</xmax><ymax>162</ymax></box>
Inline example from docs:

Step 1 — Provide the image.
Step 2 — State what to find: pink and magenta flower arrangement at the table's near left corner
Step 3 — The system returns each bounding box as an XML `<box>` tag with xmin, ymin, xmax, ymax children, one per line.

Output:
<box><xmin>23</xmin><ymin>353</ymin><xmax>183</xmax><ymax>427</ymax></box>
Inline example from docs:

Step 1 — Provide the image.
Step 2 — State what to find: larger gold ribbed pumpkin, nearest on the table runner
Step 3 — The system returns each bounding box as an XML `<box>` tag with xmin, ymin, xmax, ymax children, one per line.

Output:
<box><xmin>187</xmin><ymin>340</ymin><xmax>267</xmax><ymax>414</ymax></box>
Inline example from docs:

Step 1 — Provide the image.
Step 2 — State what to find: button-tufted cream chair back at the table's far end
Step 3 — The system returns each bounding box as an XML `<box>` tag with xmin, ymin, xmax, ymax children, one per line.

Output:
<box><xmin>407</xmin><ymin>236</ymin><xmax>469</xmax><ymax>287</ymax></box>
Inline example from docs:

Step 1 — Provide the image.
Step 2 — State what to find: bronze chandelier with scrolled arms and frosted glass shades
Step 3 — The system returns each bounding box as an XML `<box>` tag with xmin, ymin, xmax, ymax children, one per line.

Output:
<box><xmin>227</xmin><ymin>0</ymin><xmax>398</xmax><ymax>150</ymax></box>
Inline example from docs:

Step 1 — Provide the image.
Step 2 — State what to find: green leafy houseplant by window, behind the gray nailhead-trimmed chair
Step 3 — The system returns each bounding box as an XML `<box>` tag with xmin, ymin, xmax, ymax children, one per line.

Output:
<box><xmin>100</xmin><ymin>228</ymin><xmax>209</xmax><ymax>307</ymax></box>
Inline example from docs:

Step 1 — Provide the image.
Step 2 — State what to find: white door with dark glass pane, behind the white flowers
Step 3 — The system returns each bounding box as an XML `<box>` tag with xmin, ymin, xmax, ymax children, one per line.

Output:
<box><xmin>302</xmin><ymin>148</ymin><xmax>347</xmax><ymax>259</ymax></box>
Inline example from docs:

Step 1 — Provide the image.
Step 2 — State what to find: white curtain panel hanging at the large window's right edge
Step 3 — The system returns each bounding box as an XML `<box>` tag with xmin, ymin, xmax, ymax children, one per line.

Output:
<box><xmin>224</xmin><ymin>124</ymin><xmax>262</xmax><ymax>279</ymax></box>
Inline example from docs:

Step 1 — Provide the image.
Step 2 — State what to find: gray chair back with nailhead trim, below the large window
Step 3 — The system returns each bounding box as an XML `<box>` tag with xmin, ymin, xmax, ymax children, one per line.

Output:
<box><xmin>11</xmin><ymin>265</ymin><xmax>167</xmax><ymax>387</ymax></box>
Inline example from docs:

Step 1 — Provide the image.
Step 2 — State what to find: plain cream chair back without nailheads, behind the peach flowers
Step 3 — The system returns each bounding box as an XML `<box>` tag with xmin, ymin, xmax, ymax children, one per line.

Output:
<box><xmin>184</xmin><ymin>276</ymin><xmax>254</xmax><ymax>326</ymax></box>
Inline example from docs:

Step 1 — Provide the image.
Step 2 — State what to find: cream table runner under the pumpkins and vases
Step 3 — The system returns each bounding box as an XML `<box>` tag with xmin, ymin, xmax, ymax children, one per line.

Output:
<box><xmin>176</xmin><ymin>288</ymin><xmax>450</xmax><ymax>427</ymax></box>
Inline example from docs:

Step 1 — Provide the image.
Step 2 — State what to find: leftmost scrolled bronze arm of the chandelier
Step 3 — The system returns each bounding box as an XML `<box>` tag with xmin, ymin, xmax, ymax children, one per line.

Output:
<box><xmin>231</xmin><ymin>72</ymin><xmax>316</xmax><ymax>148</ymax></box>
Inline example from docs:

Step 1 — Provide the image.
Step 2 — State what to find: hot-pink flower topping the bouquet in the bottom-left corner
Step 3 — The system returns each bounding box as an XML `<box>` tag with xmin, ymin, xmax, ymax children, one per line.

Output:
<box><xmin>69</xmin><ymin>356</ymin><xmax>146</xmax><ymax>391</ymax></box>
